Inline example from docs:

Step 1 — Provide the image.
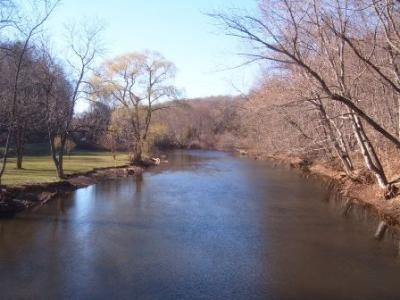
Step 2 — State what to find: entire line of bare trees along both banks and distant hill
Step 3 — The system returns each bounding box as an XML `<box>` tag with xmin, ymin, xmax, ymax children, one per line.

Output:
<box><xmin>0</xmin><ymin>0</ymin><xmax>400</xmax><ymax>202</ymax></box>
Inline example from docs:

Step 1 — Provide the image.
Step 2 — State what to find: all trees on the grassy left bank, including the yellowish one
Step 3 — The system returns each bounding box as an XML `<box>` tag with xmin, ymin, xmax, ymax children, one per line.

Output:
<box><xmin>0</xmin><ymin>0</ymin><xmax>177</xmax><ymax>184</ymax></box>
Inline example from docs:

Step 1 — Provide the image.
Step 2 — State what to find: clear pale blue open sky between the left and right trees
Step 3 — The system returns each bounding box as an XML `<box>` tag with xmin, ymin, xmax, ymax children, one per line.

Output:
<box><xmin>48</xmin><ymin>0</ymin><xmax>258</xmax><ymax>98</ymax></box>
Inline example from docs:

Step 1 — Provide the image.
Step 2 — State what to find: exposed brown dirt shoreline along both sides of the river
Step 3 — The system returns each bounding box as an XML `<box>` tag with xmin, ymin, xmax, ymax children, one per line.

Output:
<box><xmin>0</xmin><ymin>150</ymin><xmax>400</xmax><ymax>238</ymax></box>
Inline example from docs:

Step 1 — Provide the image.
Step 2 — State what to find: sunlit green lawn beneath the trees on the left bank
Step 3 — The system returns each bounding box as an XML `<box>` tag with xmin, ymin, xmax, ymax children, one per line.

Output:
<box><xmin>2</xmin><ymin>152</ymin><xmax>128</xmax><ymax>185</ymax></box>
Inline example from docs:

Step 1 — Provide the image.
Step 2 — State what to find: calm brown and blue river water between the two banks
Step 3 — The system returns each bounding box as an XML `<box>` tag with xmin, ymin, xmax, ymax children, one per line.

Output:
<box><xmin>0</xmin><ymin>151</ymin><xmax>400</xmax><ymax>299</ymax></box>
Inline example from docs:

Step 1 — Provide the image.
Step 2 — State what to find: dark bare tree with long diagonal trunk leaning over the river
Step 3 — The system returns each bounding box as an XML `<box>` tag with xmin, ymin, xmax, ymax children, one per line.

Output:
<box><xmin>211</xmin><ymin>0</ymin><xmax>400</xmax><ymax>147</ymax></box>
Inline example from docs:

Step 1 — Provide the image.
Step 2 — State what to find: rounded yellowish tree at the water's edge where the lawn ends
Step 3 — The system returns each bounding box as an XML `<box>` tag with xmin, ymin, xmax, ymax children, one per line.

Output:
<box><xmin>92</xmin><ymin>51</ymin><xmax>176</xmax><ymax>162</ymax></box>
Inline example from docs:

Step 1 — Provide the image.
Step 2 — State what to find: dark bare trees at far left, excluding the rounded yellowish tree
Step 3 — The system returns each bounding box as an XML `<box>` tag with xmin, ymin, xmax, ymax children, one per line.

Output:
<box><xmin>0</xmin><ymin>0</ymin><xmax>101</xmax><ymax>183</ymax></box>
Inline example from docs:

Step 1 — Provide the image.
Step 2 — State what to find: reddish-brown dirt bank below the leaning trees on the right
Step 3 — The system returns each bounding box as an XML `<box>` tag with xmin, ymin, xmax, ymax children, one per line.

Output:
<box><xmin>248</xmin><ymin>153</ymin><xmax>400</xmax><ymax>232</ymax></box>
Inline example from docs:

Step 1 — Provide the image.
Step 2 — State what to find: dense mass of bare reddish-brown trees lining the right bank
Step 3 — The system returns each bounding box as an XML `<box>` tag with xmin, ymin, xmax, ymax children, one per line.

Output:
<box><xmin>212</xmin><ymin>0</ymin><xmax>400</xmax><ymax>197</ymax></box>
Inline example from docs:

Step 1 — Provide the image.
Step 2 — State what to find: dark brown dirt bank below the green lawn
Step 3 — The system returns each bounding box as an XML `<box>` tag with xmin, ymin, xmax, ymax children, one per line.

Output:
<box><xmin>0</xmin><ymin>164</ymin><xmax>144</xmax><ymax>217</ymax></box>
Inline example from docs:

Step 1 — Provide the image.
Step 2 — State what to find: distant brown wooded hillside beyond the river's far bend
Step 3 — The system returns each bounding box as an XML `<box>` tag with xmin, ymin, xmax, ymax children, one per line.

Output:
<box><xmin>154</xmin><ymin>96</ymin><xmax>243</xmax><ymax>150</ymax></box>
